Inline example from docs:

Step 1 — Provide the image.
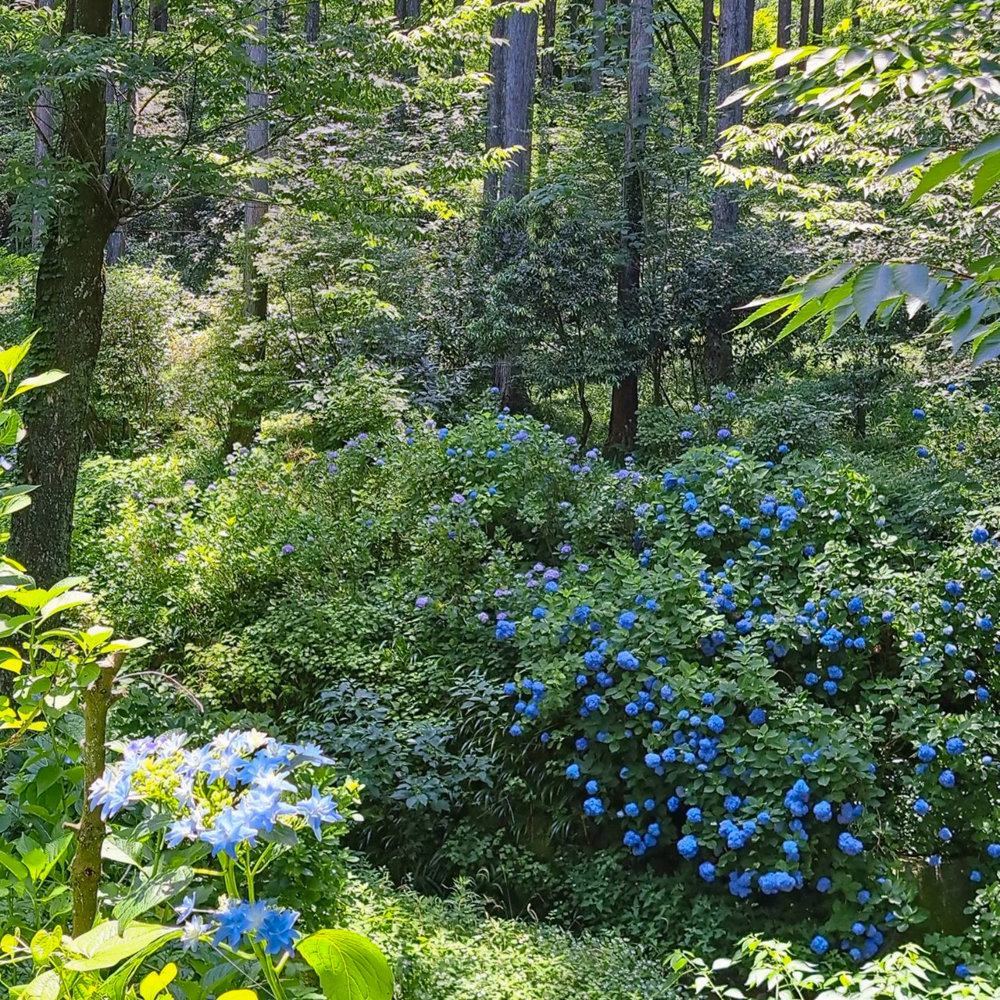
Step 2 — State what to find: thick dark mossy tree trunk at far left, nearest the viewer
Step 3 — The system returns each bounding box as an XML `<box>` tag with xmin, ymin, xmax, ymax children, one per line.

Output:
<box><xmin>7</xmin><ymin>0</ymin><xmax>118</xmax><ymax>586</ymax></box>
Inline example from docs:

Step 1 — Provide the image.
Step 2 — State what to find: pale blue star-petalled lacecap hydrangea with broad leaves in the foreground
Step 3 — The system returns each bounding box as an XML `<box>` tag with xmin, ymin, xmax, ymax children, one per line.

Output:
<box><xmin>5</xmin><ymin>730</ymin><xmax>392</xmax><ymax>1000</ymax></box>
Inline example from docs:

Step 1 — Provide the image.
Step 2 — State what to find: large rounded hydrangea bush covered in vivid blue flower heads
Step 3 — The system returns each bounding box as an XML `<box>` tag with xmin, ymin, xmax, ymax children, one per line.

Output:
<box><xmin>458</xmin><ymin>436</ymin><xmax>1000</xmax><ymax>961</ymax></box>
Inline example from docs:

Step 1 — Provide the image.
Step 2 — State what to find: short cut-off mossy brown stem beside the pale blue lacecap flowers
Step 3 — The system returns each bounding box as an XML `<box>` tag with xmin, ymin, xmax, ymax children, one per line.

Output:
<box><xmin>69</xmin><ymin>652</ymin><xmax>125</xmax><ymax>937</ymax></box>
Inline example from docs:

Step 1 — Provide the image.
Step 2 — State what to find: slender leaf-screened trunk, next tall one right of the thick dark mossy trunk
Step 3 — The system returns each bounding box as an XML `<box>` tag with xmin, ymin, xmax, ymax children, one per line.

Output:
<box><xmin>225</xmin><ymin>0</ymin><xmax>270</xmax><ymax>452</ymax></box>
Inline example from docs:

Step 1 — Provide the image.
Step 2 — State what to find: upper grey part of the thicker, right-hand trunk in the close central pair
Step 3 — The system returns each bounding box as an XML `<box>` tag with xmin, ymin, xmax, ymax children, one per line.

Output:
<box><xmin>499</xmin><ymin>11</ymin><xmax>538</xmax><ymax>201</ymax></box>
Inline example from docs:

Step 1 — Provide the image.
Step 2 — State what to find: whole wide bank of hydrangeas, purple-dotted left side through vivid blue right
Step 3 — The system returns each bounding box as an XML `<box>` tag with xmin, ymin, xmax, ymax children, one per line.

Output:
<box><xmin>70</xmin><ymin>392</ymin><xmax>1000</xmax><ymax>972</ymax></box>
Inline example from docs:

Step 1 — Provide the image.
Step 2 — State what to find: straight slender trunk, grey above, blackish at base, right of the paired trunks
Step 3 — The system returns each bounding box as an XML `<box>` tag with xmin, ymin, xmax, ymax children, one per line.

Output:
<box><xmin>607</xmin><ymin>0</ymin><xmax>653</xmax><ymax>447</ymax></box>
